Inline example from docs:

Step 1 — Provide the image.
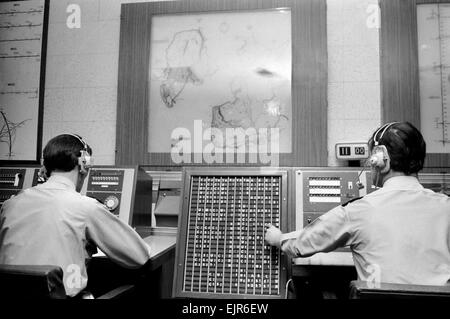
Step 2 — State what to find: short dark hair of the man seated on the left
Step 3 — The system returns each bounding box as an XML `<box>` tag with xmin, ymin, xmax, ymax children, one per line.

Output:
<box><xmin>43</xmin><ymin>134</ymin><xmax>92</xmax><ymax>176</ymax></box>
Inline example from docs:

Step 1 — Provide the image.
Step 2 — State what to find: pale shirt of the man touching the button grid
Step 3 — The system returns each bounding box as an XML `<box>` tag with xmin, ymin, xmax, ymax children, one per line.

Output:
<box><xmin>281</xmin><ymin>176</ymin><xmax>450</xmax><ymax>285</ymax></box>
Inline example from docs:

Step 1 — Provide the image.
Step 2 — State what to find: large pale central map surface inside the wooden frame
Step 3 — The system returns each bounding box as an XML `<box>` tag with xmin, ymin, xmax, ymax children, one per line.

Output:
<box><xmin>148</xmin><ymin>9</ymin><xmax>292</xmax><ymax>153</ymax></box>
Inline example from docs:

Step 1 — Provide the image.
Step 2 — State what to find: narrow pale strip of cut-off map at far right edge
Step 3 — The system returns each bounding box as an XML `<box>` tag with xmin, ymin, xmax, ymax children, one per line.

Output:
<box><xmin>417</xmin><ymin>4</ymin><xmax>450</xmax><ymax>153</ymax></box>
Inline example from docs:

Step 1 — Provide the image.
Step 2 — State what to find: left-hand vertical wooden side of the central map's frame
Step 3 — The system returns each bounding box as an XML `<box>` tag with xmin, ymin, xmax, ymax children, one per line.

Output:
<box><xmin>116</xmin><ymin>6</ymin><xmax>150</xmax><ymax>165</ymax></box>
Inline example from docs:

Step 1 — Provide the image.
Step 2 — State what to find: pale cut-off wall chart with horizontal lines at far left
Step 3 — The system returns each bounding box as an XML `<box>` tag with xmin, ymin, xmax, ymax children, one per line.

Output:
<box><xmin>0</xmin><ymin>0</ymin><xmax>45</xmax><ymax>161</ymax></box>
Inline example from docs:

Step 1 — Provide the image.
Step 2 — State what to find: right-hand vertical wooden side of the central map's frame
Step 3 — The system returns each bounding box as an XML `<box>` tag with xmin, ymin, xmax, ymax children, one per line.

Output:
<box><xmin>288</xmin><ymin>0</ymin><xmax>328</xmax><ymax>166</ymax></box>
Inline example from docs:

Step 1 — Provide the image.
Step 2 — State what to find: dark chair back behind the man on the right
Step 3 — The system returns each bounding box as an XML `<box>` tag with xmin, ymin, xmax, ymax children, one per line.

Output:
<box><xmin>350</xmin><ymin>280</ymin><xmax>450</xmax><ymax>301</ymax></box>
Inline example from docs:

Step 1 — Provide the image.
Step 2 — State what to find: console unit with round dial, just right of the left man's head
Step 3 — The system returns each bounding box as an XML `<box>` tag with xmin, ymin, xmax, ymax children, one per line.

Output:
<box><xmin>81</xmin><ymin>166</ymin><xmax>152</xmax><ymax>226</ymax></box>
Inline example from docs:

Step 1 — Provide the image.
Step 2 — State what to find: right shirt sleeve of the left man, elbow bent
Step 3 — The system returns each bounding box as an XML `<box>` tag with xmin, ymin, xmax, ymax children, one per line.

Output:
<box><xmin>86</xmin><ymin>202</ymin><xmax>150</xmax><ymax>268</ymax></box>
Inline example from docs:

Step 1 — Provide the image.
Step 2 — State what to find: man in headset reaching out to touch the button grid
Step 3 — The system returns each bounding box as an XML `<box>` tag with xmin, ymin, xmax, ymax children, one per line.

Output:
<box><xmin>265</xmin><ymin>122</ymin><xmax>450</xmax><ymax>285</ymax></box>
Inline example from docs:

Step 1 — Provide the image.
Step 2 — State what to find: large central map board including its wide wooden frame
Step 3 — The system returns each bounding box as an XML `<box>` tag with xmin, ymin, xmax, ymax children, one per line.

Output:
<box><xmin>116</xmin><ymin>0</ymin><xmax>327</xmax><ymax>166</ymax></box>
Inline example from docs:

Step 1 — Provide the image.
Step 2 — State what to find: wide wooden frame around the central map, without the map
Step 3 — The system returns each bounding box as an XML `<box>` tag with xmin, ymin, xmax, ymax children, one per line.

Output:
<box><xmin>116</xmin><ymin>0</ymin><xmax>327</xmax><ymax>166</ymax></box>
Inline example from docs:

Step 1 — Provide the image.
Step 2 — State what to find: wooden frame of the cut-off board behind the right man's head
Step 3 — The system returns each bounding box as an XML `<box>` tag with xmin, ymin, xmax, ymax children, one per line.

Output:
<box><xmin>380</xmin><ymin>0</ymin><xmax>450</xmax><ymax>167</ymax></box>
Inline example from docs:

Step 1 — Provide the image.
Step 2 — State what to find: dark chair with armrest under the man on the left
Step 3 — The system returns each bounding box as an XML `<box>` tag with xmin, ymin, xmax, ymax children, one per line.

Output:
<box><xmin>0</xmin><ymin>265</ymin><xmax>134</xmax><ymax>299</ymax></box>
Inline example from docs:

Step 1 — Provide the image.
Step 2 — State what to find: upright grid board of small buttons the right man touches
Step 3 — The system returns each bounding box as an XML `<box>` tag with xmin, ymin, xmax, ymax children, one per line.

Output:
<box><xmin>174</xmin><ymin>174</ymin><xmax>283</xmax><ymax>298</ymax></box>
